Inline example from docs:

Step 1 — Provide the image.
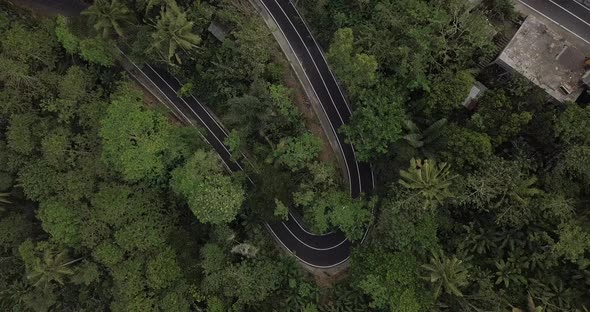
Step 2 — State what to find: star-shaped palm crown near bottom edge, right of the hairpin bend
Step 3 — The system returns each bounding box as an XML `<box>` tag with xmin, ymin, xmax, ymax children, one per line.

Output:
<box><xmin>422</xmin><ymin>251</ymin><xmax>469</xmax><ymax>298</ymax></box>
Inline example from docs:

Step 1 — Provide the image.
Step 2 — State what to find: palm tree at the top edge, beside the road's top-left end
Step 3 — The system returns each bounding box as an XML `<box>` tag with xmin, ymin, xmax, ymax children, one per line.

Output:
<box><xmin>82</xmin><ymin>0</ymin><xmax>132</xmax><ymax>38</ymax></box>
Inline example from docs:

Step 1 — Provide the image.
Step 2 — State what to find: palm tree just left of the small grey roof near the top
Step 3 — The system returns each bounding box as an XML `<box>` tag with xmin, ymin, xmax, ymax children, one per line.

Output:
<box><xmin>150</xmin><ymin>1</ymin><xmax>201</xmax><ymax>64</ymax></box>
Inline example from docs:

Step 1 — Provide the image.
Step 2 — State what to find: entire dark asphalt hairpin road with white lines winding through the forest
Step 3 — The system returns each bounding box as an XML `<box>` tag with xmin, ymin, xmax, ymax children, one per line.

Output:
<box><xmin>22</xmin><ymin>0</ymin><xmax>374</xmax><ymax>269</ymax></box>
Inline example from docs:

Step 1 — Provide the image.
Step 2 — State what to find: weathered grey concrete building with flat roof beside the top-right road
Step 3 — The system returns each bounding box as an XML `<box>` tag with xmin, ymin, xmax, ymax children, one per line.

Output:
<box><xmin>495</xmin><ymin>16</ymin><xmax>590</xmax><ymax>102</ymax></box>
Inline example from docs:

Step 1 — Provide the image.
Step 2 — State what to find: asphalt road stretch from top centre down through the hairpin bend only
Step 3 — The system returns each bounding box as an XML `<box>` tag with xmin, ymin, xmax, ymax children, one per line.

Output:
<box><xmin>261</xmin><ymin>0</ymin><xmax>374</xmax><ymax>268</ymax></box>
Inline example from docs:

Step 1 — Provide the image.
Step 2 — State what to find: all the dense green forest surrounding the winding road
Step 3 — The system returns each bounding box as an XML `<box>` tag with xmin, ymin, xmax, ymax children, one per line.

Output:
<box><xmin>0</xmin><ymin>0</ymin><xmax>590</xmax><ymax>312</ymax></box>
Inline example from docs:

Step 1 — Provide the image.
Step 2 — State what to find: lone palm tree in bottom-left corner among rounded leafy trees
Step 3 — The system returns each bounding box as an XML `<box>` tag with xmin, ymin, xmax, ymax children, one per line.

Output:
<box><xmin>27</xmin><ymin>249</ymin><xmax>83</xmax><ymax>289</ymax></box>
